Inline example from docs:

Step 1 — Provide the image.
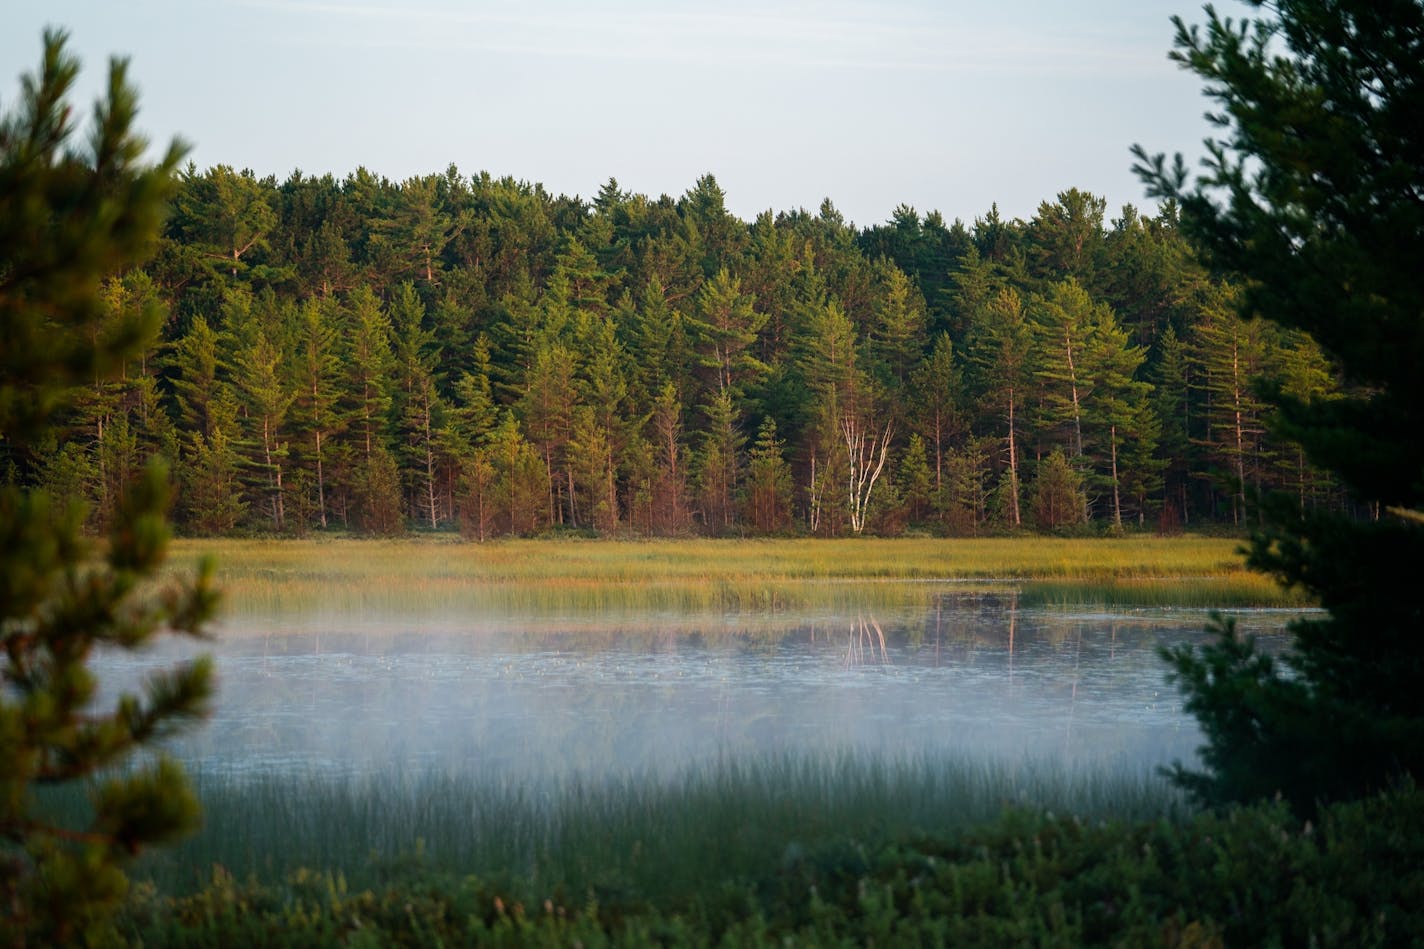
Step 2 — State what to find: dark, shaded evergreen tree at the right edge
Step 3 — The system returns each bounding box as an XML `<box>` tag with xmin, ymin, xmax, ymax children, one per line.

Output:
<box><xmin>1135</xmin><ymin>0</ymin><xmax>1424</xmax><ymax>811</ymax></box>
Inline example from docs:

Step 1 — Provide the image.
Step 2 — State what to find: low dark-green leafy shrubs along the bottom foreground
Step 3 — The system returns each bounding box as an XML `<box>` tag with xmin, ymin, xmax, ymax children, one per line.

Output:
<box><xmin>111</xmin><ymin>781</ymin><xmax>1424</xmax><ymax>946</ymax></box>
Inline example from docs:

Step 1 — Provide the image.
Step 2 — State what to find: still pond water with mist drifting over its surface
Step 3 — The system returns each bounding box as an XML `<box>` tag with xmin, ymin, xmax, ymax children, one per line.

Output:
<box><xmin>98</xmin><ymin>596</ymin><xmax>1290</xmax><ymax>779</ymax></box>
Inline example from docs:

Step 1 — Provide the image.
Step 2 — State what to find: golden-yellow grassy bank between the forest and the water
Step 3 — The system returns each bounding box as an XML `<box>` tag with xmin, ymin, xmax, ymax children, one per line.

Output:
<box><xmin>163</xmin><ymin>537</ymin><xmax>1309</xmax><ymax>618</ymax></box>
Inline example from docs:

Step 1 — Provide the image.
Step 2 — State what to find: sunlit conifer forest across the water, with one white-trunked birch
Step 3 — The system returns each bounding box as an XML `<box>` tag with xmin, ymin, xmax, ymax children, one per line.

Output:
<box><xmin>27</xmin><ymin>165</ymin><xmax>1346</xmax><ymax>539</ymax></box>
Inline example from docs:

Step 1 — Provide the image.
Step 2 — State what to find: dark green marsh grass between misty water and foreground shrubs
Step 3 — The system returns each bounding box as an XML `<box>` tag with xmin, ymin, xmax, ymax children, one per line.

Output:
<box><xmin>105</xmin><ymin>754</ymin><xmax>1183</xmax><ymax>903</ymax></box>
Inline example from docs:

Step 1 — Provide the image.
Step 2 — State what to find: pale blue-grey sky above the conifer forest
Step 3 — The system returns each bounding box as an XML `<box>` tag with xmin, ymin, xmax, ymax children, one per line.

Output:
<box><xmin>0</xmin><ymin>0</ymin><xmax>1243</xmax><ymax>227</ymax></box>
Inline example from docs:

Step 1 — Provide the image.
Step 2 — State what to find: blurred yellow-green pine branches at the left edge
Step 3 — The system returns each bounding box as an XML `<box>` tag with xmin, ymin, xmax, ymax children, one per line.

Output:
<box><xmin>0</xmin><ymin>33</ymin><xmax>215</xmax><ymax>945</ymax></box>
